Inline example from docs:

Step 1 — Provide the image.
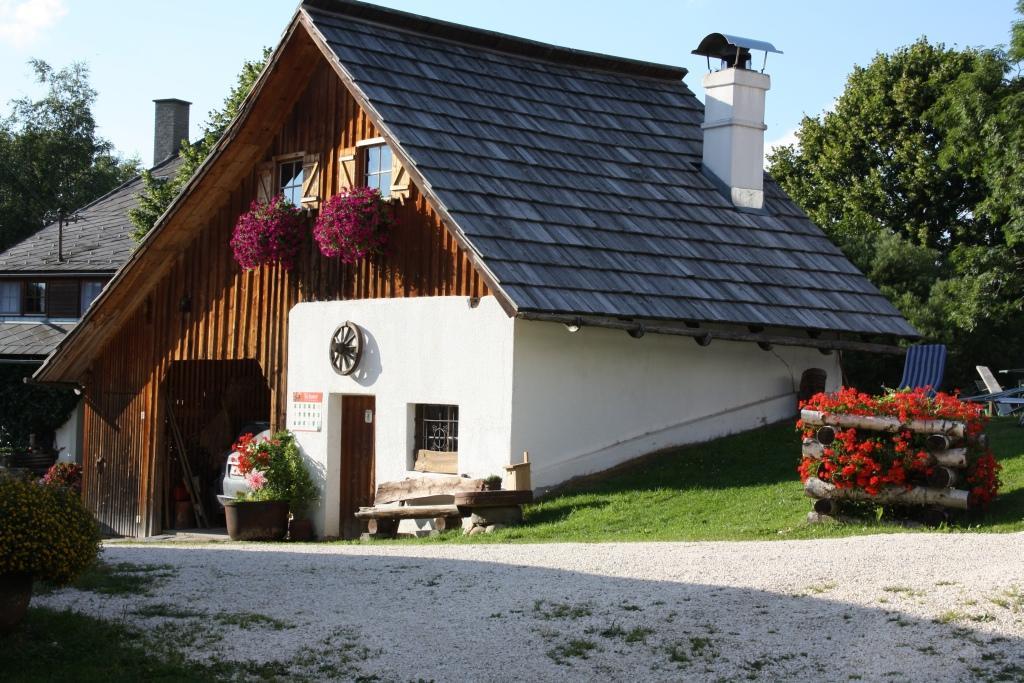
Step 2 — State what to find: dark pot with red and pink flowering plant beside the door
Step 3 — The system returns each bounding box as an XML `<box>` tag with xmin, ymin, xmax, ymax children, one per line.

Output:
<box><xmin>224</xmin><ymin>431</ymin><xmax>316</xmax><ymax>541</ymax></box>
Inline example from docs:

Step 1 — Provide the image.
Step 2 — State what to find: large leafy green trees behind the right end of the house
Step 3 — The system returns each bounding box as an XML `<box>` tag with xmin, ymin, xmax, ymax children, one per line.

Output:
<box><xmin>769</xmin><ymin>29</ymin><xmax>1024</xmax><ymax>390</ymax></box>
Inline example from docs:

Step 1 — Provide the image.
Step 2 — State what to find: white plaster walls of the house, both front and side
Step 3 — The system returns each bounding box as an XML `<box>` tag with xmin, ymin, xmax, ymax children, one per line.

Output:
<box><xmin>288</xmin><ymin>297</ymin><xmax>841</xmax><ymax>536</ymax></box>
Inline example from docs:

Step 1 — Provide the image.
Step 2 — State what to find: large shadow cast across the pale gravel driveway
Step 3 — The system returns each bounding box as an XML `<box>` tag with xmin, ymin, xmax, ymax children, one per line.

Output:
<box><xmin>19</xmin><ymin>546</ymin><xmax>1024</xmax><ymax>681</ymax></box>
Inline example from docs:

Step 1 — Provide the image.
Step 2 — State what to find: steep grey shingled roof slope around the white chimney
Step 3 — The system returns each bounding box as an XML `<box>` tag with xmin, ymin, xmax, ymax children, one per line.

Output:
<box><xmin>302</xmin><ymin>0</ymin><xmax>916</xmax><ymax>336</ymax></box>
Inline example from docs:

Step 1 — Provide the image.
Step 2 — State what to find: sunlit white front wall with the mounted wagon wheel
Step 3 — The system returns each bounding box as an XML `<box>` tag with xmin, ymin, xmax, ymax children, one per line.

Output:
<box><xmin>288</xmin><ymin>296</ymin><xmax>514</xmax><ymax>536</ymax></box>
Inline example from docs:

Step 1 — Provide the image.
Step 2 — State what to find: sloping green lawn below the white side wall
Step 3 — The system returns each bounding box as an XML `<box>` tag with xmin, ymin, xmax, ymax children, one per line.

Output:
<box><xmin>399</xmin><ymin>418</ymin><xmax>1024</xmax><ymax>543</ymax></box>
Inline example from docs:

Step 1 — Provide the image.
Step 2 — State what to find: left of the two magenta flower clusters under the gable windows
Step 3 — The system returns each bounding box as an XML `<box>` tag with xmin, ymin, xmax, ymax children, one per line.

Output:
<box><xmin>231</xmin><ymin>195</ymin><xmax>304</xmax><ymax>270</ymax></box>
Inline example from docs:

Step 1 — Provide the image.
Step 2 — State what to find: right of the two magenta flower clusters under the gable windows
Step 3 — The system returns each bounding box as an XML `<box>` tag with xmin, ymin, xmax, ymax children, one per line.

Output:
<box><xmin>313</xmin><ymin>187</ymin><xmax>395</xmax><ymax>263</ymax></box>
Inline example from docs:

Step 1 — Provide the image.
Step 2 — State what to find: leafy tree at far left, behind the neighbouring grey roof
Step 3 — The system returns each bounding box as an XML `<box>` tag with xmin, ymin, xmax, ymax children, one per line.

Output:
<box><xmin>0</xmin><ymin>59</ymin><xmax>138</xmax><ymax>250</ymax></box>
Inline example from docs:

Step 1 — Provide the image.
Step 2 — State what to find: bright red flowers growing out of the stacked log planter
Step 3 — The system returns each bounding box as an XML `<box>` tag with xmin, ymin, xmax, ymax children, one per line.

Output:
<box><xmin>797</xmin><ymin>388</ymin><xmax>1000</xmax><ymax>505</ymax></box>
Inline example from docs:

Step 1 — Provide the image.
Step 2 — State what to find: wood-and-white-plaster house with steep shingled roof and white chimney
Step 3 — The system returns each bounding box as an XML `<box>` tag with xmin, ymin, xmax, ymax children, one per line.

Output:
<box><xmin>37</xmin><ymin>0</ymin><xmax>916</xmax><ymax>536</ymax></box>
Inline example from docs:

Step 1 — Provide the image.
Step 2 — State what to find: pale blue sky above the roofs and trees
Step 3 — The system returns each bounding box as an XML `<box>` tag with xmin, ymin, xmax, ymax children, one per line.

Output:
<box><xmin>0</xmin><ymin>0</ymin><xmax>1015</xmax><ymax>164</ymax></box>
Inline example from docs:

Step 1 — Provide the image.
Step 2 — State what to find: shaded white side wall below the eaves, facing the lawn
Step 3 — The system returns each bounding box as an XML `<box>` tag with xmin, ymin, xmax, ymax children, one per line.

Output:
<box><xmin>512</xmin><ymin>321</ymin><xmax>841</xmax><ymax>488</ymax></box>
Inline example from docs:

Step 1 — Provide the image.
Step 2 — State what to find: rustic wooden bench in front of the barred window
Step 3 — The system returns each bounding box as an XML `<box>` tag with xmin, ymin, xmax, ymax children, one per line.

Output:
<box><xmin>355</xmin><ymin>476</ymin><xmax>483</xmax><ymax>540</ymax></box>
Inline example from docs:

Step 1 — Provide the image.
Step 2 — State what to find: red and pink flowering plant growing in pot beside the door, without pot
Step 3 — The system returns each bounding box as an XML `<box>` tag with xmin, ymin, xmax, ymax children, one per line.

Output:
<box><xmin>233</xmin><ymin>431</ymin><xmax>316</xmax><ymax>515</ymax></box>
